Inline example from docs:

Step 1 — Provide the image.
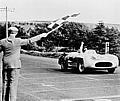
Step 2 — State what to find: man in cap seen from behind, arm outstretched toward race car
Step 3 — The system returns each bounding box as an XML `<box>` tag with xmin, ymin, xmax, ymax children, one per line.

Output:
<box><xmin>0</xmin><ymin>27</ymin><xmax>48</xmax><ymax>101</ymax></box>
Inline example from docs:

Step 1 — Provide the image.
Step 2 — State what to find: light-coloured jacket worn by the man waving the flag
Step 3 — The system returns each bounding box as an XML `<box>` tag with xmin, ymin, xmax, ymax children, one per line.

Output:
<box><xmin>0</xmin><ymin>35</ymin><xmax>40</xmax><ymax>69</ymax></box>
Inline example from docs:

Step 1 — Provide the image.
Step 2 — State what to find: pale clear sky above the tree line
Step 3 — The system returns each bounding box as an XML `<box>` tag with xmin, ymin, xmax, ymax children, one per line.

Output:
<box><xmin>0</xmin><ymin>0</ymin><xmax>120</xmax><ymax>24</ymax></box>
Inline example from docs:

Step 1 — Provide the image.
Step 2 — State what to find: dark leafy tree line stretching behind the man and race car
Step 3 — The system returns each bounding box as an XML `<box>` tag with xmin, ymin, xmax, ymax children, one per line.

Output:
<box><xmin>0</xmin><ymin>22</ymin><xmax>120</xmax><ymax>56</ymax></box>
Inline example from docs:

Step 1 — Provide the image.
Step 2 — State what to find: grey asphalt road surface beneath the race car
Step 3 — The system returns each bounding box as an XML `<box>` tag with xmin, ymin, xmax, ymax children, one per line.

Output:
<box><xmin>0</xmin><ymin>55</ymin><xmax>120</xmax><ymax>101</ymax></box>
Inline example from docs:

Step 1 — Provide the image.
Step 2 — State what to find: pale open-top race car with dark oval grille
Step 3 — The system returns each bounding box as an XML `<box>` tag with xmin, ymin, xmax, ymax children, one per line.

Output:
<box><xmin>58</xmin><ymin>49</ymin><xmax>119</xmax><ymax>73</ymax></box>
